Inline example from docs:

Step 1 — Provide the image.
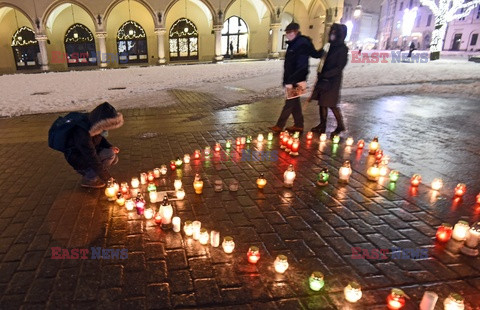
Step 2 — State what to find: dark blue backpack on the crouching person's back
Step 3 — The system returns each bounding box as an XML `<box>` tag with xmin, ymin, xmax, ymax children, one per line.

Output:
<box><xmin>48</xmin><ymin>112</ymin><xmax>90</xmax><ymax>153</ymax></box>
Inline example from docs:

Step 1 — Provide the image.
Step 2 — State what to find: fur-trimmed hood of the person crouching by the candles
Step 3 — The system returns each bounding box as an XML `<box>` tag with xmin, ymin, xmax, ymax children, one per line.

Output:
<box><xmin>88</xmin><ymin>102</ymin><xmax>123</xmax><ymax>137</ymax></box>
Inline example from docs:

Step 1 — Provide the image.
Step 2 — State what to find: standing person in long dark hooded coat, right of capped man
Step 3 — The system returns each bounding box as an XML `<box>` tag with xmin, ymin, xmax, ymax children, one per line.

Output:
<box><xmin>311</xmin><ymin>24</ymin><xmax>348</xmax><ymax>137</ymax></box>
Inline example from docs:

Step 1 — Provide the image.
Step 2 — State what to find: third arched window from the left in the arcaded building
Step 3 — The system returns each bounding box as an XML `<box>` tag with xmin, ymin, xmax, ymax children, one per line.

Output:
<box><xmin>117</xmin><ymin>20</ymin><xmax>148</xmax><ymax>63</ymax></box>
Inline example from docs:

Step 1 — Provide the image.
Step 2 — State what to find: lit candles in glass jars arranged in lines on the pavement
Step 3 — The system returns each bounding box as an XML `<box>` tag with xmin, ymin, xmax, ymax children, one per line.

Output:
<box><xmin>106</xmin><ymin>132</ymin><xmax>472</xmax><ymax>309</ymax></box>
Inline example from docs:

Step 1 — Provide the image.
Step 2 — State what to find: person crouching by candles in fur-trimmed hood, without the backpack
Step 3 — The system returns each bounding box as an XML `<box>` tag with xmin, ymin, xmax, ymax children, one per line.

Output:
<box><xmin>65</xmin><ymin>102</ymin><xmax>123</xmax><ymax>188</ymax></box>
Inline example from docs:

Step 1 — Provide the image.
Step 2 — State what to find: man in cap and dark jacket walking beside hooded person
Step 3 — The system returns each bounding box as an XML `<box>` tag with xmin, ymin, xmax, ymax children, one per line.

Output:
<box><xmin>269</xmin><ymin>23</ymin><xmax>316</xmax><ymax>133</ymax></box>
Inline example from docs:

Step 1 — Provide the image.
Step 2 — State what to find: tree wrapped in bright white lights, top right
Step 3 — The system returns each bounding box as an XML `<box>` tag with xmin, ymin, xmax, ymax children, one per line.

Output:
<box><xmin>420</xmin><ymin>0</ymin><xmax>480</xmax><ymax>60</ymax></box>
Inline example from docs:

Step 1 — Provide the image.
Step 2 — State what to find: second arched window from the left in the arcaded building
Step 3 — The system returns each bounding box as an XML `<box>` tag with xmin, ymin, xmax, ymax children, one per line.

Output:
<box><xmin>65</xmin><ymin>24</ymin><xmax>97</xmax><ymax>67</ymax></box>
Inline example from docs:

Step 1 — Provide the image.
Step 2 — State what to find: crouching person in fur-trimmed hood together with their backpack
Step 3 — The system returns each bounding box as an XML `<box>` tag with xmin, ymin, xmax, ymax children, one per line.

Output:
<box><xmin>48</xmin><ymin>102</ymin><xmax>123</xmax><ymax>188</ymax></box>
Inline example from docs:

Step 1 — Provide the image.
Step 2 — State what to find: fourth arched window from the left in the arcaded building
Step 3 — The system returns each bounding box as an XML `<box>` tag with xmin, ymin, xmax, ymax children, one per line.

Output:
<box><xmin>169</xmin><ymin>18</ymin><xmax>198</xmax><ymax>61</ymax></box>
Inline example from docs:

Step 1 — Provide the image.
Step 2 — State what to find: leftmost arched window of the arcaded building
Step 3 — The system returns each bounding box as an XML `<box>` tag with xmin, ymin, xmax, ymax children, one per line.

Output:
<box><xmin>12</xmin><ymin>27</ymin><xmax>40</xmax><ymax>70</ymax></box>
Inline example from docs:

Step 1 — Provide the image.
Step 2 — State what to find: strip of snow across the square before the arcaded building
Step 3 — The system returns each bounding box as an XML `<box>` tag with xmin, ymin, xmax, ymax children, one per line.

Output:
<box><xmin>0</xmin><ymin>52</ymin><xmax>480</xmax><ymax>116</ymax></box>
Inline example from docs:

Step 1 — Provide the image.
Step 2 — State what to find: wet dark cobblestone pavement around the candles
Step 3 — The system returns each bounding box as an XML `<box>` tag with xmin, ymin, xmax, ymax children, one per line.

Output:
<box><xmin>0</xmin><ymin>91</ymin><xmax>480</xmax><ymax>309</ymax></box>
